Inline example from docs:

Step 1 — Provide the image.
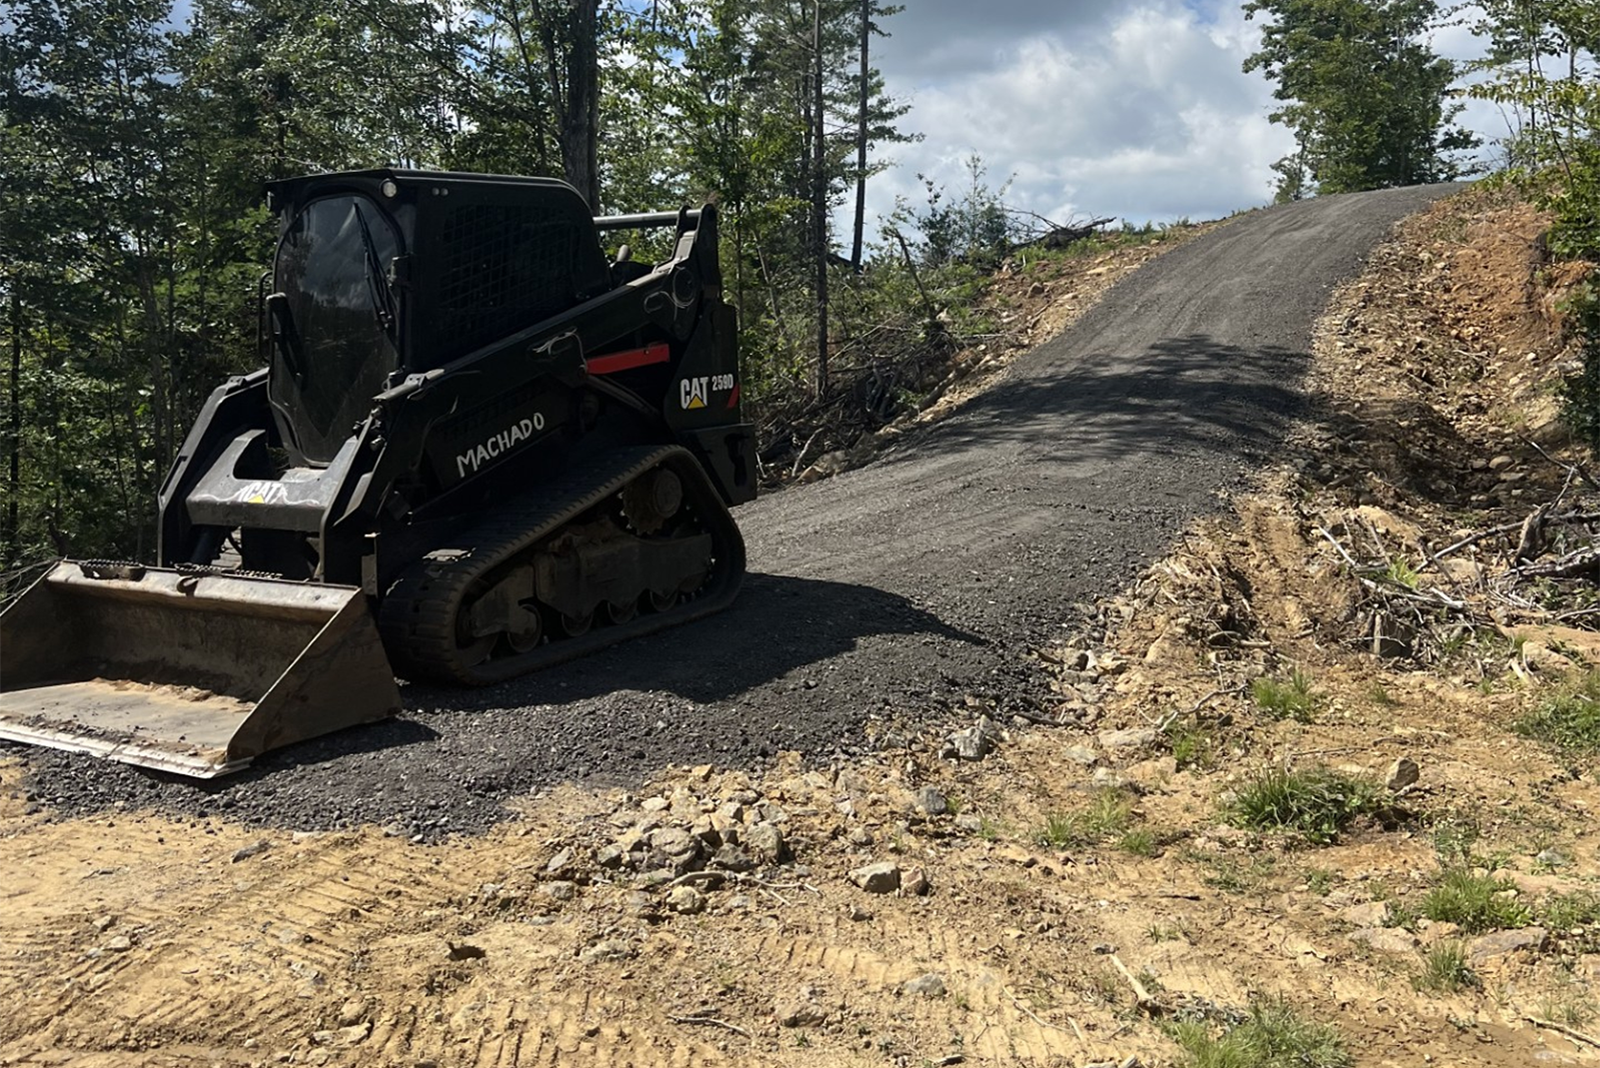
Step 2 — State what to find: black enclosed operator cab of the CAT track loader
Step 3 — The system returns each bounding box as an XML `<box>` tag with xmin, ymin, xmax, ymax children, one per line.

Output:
<box><xmin>262</xmin><ymin>169</ymin><xmax>613</xmax><ymax>467</ymax></box>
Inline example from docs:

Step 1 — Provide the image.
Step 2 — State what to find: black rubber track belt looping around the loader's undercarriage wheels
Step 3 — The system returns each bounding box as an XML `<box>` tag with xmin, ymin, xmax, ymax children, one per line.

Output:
<box><xmin>378</xmin><ymin>446</ymin><xmax>744</xmax><ymax>686</ymax></box>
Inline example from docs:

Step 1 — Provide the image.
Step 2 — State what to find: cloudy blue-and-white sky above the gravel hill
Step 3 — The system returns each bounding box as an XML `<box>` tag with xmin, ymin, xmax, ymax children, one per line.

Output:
<box><xmin>867</xmin><ymin>0</ymin><xmax>1504</xmax><ymax>231</ymax></box>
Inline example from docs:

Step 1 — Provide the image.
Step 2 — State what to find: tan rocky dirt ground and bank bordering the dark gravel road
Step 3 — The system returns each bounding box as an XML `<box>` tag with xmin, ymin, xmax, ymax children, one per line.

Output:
<box><xmin>0</xmin><ymin>185</ymin><xmax>1600</xmax><ymax>1068</ymax></box>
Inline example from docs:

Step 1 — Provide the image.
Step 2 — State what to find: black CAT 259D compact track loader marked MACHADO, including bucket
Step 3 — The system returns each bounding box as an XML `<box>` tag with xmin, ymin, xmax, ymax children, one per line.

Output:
<box><xmin>0</xmin><ymin>169</ymin><xmax>755</xmax><ymax>777</ymax></box>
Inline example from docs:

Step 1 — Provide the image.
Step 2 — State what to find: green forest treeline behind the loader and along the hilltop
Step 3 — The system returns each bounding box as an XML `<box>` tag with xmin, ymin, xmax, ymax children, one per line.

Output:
<box><xmin>0</xmin><ymin>0</ymin><xmax>1600</xmax><ymax>564</ymax></box>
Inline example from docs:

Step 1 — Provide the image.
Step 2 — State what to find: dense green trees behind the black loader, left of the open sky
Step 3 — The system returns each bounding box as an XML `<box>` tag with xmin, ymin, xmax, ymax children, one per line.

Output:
<box><xmin>0</xmin><ymin>0</ymin><xmax>928</xmax><ymax>564</ymax></box>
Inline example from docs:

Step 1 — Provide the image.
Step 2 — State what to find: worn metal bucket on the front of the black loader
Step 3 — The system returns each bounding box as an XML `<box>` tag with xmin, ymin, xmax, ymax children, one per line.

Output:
<box><xmin>0</xmin><ymin>561</ymin><xmax>400</xmax><ymax>779</ymax></box>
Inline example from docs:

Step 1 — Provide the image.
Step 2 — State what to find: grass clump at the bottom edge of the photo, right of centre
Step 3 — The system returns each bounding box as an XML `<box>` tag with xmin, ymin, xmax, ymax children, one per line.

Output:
<box><xmin>1166</xmin><ymin>999</ymin><xmax>1355</xmax><ymax>1068</ymax></box>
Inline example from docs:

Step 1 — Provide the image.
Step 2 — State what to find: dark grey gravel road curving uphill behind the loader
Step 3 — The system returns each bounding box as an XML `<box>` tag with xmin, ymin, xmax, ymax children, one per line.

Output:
<box><xmin>10</xmin><ymin>185</ymin><xmax>1454</xmax><ymax>838</ymax></box>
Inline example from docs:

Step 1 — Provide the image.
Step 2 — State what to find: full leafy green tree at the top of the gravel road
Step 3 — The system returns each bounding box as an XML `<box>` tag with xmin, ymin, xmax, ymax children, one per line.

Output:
<box><xmin>1245</xmin><ymin>0</ymin><xmax>1477</xmax><ymax>200</ymax></box>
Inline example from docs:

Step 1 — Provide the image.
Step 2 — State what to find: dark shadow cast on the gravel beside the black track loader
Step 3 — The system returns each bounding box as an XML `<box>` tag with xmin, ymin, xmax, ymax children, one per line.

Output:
<box><xmin>400</xmin><ymin>572</ymin><xmax>987</xmax><ymax>711</ymax></box>
